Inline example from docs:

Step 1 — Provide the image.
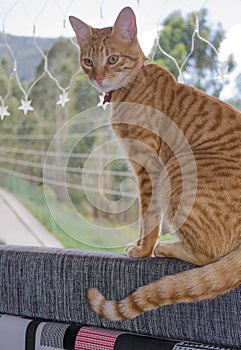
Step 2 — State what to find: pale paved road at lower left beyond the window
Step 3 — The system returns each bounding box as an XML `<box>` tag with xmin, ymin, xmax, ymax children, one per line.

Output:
<box><xmin>0</xmin><ymin>189</ymin><xmax>62</xmax><ymax>247</ymax></box>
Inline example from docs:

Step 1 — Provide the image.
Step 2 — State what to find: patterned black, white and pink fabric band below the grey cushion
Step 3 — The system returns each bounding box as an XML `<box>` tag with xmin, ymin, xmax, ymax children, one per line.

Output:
<box><xmin>0</xmin><ymin>314</ymin><xmax>233</xmax><ymax>350</ymax></box>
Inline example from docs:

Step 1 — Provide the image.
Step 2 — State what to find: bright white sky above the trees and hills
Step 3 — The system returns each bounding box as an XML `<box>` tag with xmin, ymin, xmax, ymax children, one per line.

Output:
<box><xmin>0</xmin><ymin>0</ymin><xmax>241</xmax><ymax>85</ymax></box>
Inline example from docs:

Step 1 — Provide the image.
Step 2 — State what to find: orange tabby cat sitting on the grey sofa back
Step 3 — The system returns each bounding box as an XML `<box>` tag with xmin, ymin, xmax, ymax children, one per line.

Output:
<box><xmin>70</xmin><ymin>7</ymin><xmax>241</xmax><ymax>320</ymax></box>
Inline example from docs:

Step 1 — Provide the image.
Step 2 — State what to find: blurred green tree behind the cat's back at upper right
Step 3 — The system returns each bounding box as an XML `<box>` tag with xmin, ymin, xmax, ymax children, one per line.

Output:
<box><xmin>151</xmin><ymin>9</ymin><xmax>234</xmax><ymax>97</ymax></box>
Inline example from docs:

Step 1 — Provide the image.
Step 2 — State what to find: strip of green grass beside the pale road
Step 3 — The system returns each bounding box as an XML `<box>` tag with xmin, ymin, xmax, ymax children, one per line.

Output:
<box><xmin>0</xmin><ymin>176</ymin><xmax>140</xmax><ymax>253</ymax></box>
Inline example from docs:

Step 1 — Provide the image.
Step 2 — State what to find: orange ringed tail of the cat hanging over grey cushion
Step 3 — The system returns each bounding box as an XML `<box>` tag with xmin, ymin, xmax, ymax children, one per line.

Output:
<box><xmin>88</xmin><ymin>246</ymin><xmax>241</xmax><ymax>321</ymax></box>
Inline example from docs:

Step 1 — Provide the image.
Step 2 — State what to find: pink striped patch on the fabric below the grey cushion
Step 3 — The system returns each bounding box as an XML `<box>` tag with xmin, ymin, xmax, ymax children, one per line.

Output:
<box><xmin>74</xmin><ymin>327</ymin><xmax>123</xmax><ymax>350</ymax></box>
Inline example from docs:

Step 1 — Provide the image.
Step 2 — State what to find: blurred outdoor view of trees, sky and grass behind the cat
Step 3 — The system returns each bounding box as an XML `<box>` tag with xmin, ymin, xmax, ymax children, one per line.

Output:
<box><xmin>0</xmin><ymin>0</ymin><xmax>241</xmax><ymax>251</ymax></box>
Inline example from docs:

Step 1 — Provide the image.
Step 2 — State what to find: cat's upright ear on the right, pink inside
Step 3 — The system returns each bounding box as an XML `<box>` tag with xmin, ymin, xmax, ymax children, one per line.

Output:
<box><xmin>111</xmin><ymin>7</ymin><xmax>137</xmax><ymax>41</ymax></box>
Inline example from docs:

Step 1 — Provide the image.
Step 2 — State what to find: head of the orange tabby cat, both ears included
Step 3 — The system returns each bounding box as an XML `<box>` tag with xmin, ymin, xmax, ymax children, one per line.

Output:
<box><xmin>69</xmin><ymin>7</ymin><xmax>146</xmax><ymax>92</ymax></box>
